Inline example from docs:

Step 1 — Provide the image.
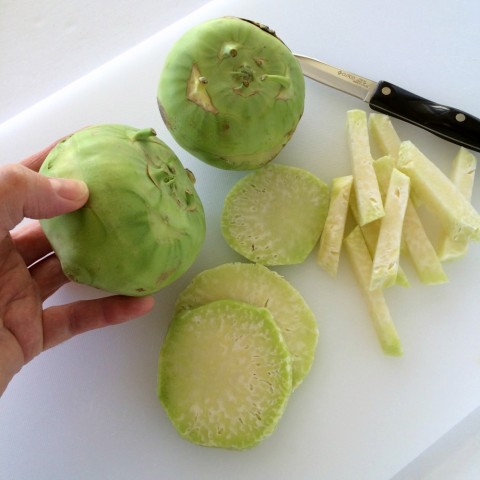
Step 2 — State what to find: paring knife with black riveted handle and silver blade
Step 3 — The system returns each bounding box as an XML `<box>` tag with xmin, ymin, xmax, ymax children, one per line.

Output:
<box><xmin>295</xmin><ymin>54</ymin><xmax>480</xmax><ymax>152</ymax></box>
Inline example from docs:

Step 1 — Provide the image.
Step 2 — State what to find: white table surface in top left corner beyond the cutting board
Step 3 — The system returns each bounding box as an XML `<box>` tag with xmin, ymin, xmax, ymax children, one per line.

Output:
<box><xmin>0</xmin><ymin>0</ymin><xmax>208</xmax><ymax>123</ymax></box>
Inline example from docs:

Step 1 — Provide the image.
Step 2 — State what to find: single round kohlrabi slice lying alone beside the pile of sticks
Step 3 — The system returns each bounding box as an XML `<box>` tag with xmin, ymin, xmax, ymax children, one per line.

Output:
<box><xmin>221</xmin><ymin>164</ymin><xmax>329</xmax><ymax>265</ymax></box>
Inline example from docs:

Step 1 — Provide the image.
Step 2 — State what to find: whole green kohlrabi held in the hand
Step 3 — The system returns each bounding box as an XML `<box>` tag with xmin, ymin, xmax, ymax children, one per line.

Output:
<box><xmin>40</xmin><ymin>125</ymin><xmax>205</xmax><ymax>296</ymax></box>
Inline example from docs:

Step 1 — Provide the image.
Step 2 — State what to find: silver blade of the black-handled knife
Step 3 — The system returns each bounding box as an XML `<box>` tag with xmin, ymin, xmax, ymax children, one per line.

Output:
<box><xmin>295</xmin><ymin>54</ymin><xmax>377</xmax><ymax>103</ymax></box>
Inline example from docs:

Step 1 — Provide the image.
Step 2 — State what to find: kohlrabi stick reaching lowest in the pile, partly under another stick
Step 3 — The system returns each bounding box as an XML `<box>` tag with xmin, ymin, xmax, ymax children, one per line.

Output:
<box><xmin>344</xmin><ymin>226</ymin><xmax>403</xmax><ymax>356</ymax></box>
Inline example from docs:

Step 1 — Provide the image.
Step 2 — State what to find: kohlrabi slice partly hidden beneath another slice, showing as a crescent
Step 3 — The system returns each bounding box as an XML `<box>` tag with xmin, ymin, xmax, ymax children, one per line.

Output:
<box><xmin>176</xmin><ymin>262</ymin><xmax>318</xmax><ymax>388</ymax></box>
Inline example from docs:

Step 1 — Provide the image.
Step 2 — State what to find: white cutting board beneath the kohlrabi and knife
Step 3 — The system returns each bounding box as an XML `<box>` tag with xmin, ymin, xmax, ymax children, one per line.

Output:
<box><xmin>0</xmin><ymin>0</ymin><xmax>480</xmax><ymax>480</ymax></box>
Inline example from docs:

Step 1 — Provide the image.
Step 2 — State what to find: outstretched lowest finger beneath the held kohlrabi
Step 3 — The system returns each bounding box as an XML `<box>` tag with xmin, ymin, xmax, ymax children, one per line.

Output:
<box><xmin>43</xmin><ymin>295</ymin><xmax>154</xmax><ymax>350</ymax></box>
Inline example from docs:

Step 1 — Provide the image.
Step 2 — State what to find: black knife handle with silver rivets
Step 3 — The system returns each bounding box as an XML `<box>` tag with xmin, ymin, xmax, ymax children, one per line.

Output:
<box><xmin>369</xmin><ymin>81</ymin><xmax>480</xmax><ymax>152</ymax></box>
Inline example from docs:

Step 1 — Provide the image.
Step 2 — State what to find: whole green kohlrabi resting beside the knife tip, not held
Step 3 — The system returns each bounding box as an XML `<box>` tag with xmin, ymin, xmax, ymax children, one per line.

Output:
<box><xmin>157</xmin><ymin>17</ymin><xmax>305</xmax><ymax>170</ymax></box>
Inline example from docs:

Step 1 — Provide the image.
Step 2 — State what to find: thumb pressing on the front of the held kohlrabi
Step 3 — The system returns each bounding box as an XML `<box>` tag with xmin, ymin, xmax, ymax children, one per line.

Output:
<box><xmin>0</xmin><ymin>165</ymin><xmax>88</xmax><ymax>232</ymax></box>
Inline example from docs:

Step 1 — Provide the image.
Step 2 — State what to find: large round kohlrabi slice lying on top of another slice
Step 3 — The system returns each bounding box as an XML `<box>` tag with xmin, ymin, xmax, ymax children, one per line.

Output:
<box><xmin>158</xmin><ymin>300</ymin><xmax>292</xmax><ymax>449</ymax></box>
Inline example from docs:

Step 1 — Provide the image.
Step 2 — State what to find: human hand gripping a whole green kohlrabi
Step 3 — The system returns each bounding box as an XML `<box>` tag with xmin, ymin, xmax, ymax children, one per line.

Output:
<box><xmin>0</xmin><ymin>139</ymin><xmax>153</xmax><ymax>396</ymax></box>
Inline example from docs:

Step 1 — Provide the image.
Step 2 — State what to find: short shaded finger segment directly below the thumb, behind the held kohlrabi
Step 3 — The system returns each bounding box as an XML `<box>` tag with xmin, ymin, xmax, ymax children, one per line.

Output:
<box><xmin>11</xmin><ymin>221</ymin><xmax>52</xmax><ymax>266</ymax></box>
